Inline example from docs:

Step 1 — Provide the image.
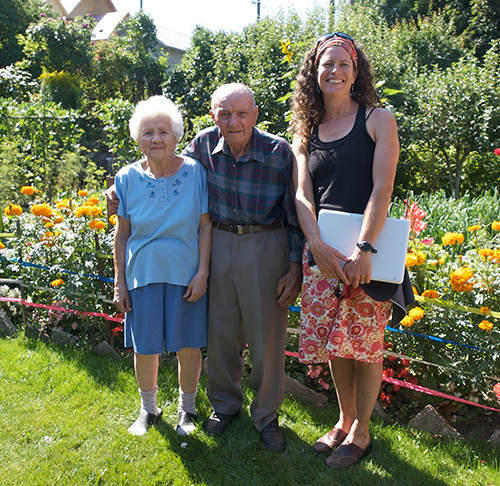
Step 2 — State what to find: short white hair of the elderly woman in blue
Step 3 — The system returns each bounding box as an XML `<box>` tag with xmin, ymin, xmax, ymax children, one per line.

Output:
<box><xmin>128</xmin><ymin>95</ymin><xmax>184</xmax><ymax>142</ymax></box>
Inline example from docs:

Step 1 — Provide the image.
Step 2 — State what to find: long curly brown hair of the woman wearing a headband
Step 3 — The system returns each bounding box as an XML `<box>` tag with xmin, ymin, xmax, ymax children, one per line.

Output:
<box><xmin>288</xmin><ymin>38</ymin><xmax>382</xmax><ymax>142</ymax></box>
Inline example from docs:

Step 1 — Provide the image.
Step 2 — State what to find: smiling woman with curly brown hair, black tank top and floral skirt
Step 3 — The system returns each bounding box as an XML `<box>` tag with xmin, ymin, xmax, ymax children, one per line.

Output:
<box><xmin>291</xmin><ymin>33</ymin><xmax>412</xmax><ymax>468</ymax></box>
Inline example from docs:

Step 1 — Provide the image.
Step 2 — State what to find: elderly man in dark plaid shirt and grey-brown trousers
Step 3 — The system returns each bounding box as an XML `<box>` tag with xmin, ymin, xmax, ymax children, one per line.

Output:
<box><xmin>184</xmin><ymin>83</ymin><xmax>302</xmax><ymax>451</ymax></box>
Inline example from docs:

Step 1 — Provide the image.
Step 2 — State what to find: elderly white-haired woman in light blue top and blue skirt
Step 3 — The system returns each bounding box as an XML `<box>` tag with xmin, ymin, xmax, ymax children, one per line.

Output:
<box><xmin>114</xmin><ymin>96</ymin><xmax>211</xmax><ymax>435</ymax></box>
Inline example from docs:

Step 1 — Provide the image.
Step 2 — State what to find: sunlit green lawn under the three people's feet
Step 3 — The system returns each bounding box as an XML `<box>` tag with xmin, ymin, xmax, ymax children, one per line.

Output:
<box><xmin>0</xmin><ymin>334</ymin><xmax>500</xmax><ymax>486</ymax></box>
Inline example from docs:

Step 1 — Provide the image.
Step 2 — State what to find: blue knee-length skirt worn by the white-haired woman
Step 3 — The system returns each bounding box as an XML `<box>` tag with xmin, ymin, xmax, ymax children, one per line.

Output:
<box><xmin>125</xmin><ymin>283</ymin><xmax>208</xmax><ymax>354</ymax></box>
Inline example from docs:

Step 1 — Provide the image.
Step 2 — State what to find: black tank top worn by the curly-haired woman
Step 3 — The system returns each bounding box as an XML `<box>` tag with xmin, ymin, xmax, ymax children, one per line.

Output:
<box><xmin>308</xmin><ymin>105</ymin><xmax>375</xmax><ymax>214</ymax></box>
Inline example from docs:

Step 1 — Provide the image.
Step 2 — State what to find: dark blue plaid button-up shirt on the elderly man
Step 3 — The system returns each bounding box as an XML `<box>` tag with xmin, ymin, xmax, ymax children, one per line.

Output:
<box><xmin>183</xmin><ymin>127</ymin><xmax>303</xmax><ymax>262</ymax></box>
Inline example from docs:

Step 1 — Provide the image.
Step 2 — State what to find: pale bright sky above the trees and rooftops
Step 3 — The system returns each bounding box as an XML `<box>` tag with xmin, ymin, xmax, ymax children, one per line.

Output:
<box><xmin>113</xmin><ymin>0</ymin><xmax>329</xmax><ymax>35</ymax></box>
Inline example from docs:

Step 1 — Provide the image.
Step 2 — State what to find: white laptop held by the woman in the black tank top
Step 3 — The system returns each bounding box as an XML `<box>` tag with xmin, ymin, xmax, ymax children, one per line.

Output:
<box><xmin>318</xmin><ymin>209</ymin><xmax>410</xmax><ymax>284</ymax></box>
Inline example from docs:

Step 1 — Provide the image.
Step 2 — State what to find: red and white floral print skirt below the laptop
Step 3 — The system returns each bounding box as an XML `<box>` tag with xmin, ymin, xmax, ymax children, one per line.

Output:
<box><xmin>299</xmin><ymin>245</ymin><xmax>392</xmax><ymax>363</ymax></box>
